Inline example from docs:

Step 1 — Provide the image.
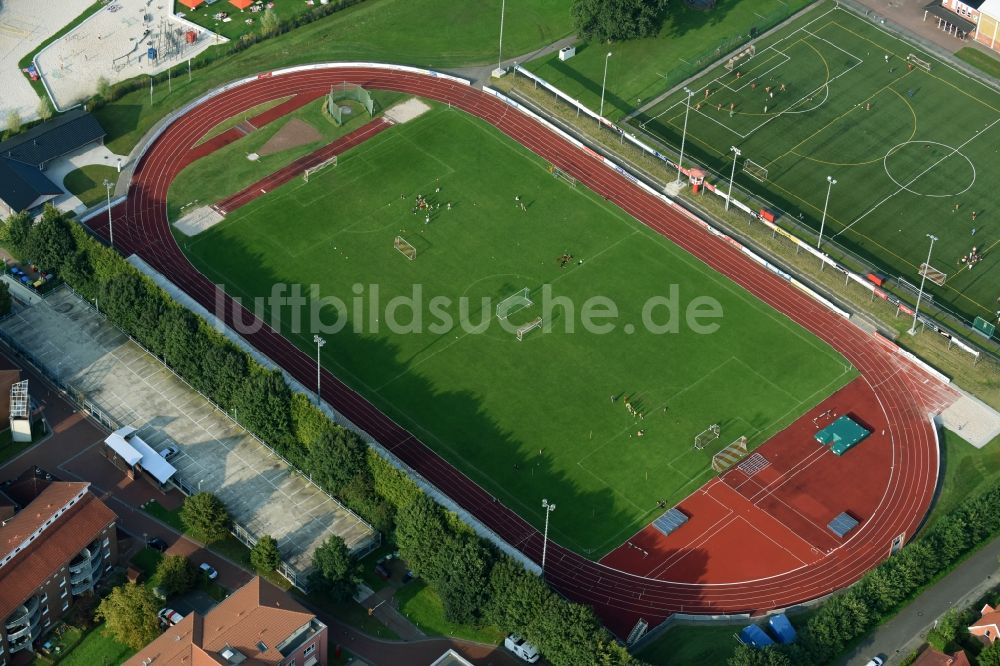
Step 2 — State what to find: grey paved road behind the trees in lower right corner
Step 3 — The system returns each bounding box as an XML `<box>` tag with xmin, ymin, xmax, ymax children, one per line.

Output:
<box><xmin>841</xmin><ymin>538</ymin><xmax>1000</xmax><ymax>666</ymax></box>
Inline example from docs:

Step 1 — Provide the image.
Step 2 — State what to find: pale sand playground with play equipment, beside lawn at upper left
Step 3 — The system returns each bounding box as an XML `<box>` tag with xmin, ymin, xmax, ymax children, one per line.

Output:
<box><xmin>35</xmin><ymin>0</ymin><xmax>227</xmax><ymax>110</ymax></box>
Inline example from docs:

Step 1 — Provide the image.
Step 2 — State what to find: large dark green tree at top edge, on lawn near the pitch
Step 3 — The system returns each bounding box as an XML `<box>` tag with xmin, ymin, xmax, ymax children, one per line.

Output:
<box><xmin>572</xmin><ymin>0</ymin><xmax>667</xmax><ymax>42</ymax></box>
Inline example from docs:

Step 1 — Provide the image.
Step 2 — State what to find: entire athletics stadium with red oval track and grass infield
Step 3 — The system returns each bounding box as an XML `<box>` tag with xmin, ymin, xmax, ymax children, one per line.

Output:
<box><xmin>90</xmin><ymin>64</ymin><xmax>954</xmax><ymax>638</ymax></box>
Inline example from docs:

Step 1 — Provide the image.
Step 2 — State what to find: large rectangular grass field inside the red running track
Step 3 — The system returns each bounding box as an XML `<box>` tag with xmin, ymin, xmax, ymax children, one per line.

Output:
<box><xmin>182</xmin><ymin>100</ymin><xmax>856</xmax><ymax>558</ymax></box>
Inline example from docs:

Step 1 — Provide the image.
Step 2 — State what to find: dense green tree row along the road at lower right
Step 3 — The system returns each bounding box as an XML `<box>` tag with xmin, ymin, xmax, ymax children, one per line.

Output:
<box><xmin>729</xmin><ymin>484</ymin><xmax>1000</xmax><ymax>666</ymax></box>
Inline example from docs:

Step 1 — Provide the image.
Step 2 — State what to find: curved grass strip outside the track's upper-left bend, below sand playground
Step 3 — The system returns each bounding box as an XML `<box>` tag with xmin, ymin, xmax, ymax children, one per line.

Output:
<box><xmin>95</xmin><ymin>0</ymin><xmax>573</xmax><ymax>155</ymax></box>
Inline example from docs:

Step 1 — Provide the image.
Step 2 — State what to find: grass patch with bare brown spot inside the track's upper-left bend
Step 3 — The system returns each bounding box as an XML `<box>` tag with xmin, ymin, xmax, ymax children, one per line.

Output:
<box><xmin>167</xmin><ymin>92</ymin><xmax>404</xmax><ymax>220</ymax></box>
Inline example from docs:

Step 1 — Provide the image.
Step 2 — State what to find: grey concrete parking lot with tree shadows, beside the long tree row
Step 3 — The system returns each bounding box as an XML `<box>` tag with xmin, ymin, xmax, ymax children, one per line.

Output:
<box><xmin>0</xmin><ymin>288</ymin><xmax>375</xmax><ymax>573</ymax></box>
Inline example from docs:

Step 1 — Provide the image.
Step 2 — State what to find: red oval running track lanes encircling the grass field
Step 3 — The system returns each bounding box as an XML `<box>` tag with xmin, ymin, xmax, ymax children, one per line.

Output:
<box><xmin>94</xmin><ymin>65</ymin><xmax>938</xmax><ymax>636</ymax></box>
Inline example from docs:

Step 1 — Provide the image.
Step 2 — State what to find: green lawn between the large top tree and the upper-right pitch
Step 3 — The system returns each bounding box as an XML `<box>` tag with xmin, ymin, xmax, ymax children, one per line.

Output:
<box><xmin>525</xmin><ymin>0</ymin><xmax>809</xmax><ymax>120</ymax></box>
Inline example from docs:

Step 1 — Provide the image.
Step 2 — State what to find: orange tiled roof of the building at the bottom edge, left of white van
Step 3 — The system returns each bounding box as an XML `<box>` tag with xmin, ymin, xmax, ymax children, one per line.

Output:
<box><xmin>125</xmin><ymin>577</ymin><xmax>314</xmax><ymax>666</ymax></box>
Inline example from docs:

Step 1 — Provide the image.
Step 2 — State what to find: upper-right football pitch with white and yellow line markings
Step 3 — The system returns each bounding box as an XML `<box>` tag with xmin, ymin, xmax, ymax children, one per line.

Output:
<box><xmin>632</xmin><ymin>3</ymin><xmax>1000</xmax><ymax>319</ymax></box>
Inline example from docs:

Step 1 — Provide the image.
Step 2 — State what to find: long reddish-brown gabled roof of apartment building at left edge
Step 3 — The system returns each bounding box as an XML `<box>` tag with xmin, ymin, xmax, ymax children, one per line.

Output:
<box><xmin>0</xmin><ymin>482</ymin><xmax>115</xmax><ymax>618</ymax></box>
